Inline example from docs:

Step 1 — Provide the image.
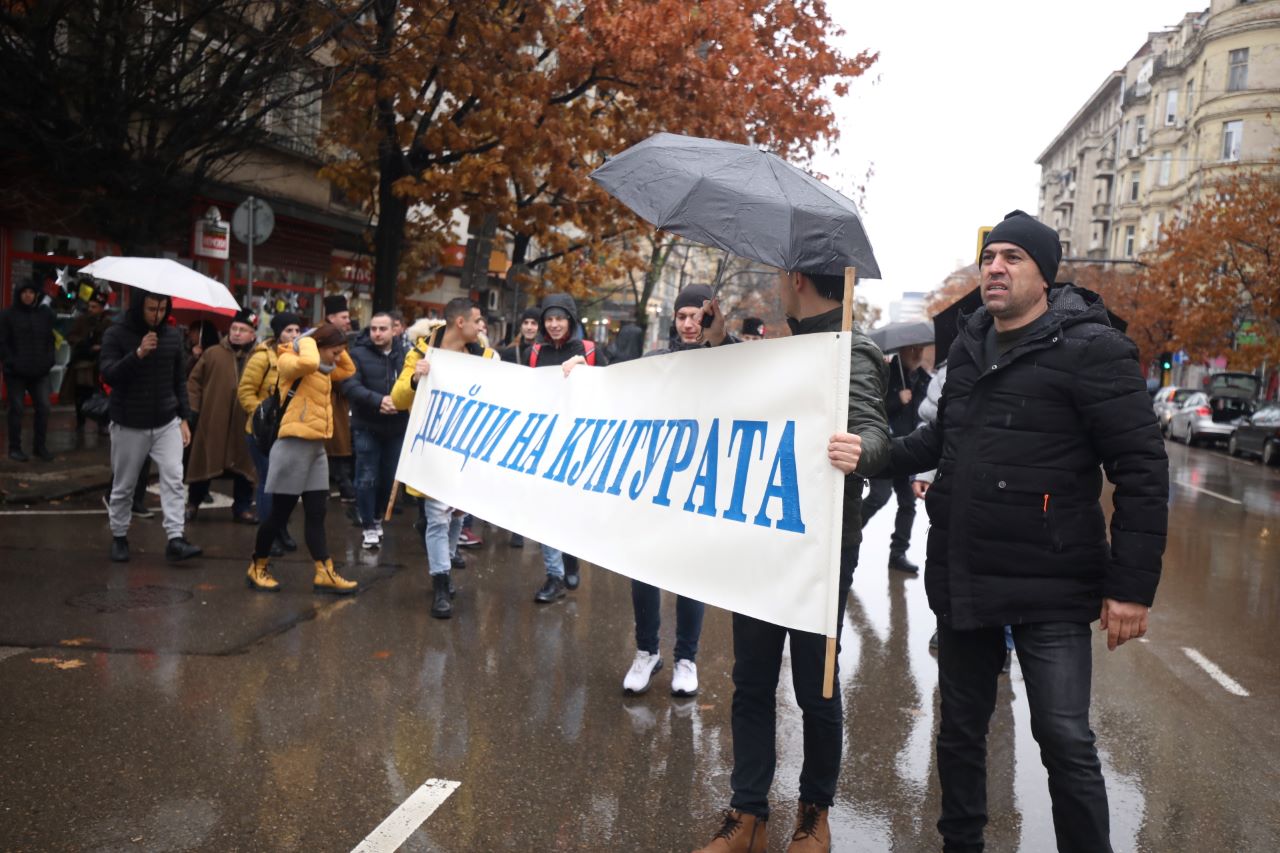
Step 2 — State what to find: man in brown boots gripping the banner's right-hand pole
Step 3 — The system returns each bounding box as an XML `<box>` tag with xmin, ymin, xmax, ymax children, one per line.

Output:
<box><xmin>699</xmin><ymin>273</ymin><xmax>888</xmax><ymax>853</ymax></box>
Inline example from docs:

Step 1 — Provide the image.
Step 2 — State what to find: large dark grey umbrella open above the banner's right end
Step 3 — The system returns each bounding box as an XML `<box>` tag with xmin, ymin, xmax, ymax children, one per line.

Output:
<box><xmin>591</xmin><ymin>133</ymin><xmax>881</xmax><ymax>278</ymax></box>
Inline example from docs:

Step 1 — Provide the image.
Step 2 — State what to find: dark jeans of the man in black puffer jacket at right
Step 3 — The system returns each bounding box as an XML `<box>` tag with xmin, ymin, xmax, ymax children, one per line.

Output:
<box><xmin>938</xmin><ymin>622</ymin><xmax>1111</xmax><ymax>853</ymax></box>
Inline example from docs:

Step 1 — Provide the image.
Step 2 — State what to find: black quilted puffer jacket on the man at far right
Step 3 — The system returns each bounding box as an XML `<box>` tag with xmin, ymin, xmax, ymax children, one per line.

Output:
<box><xmin>891</xmin><ymin>284</ymin><xmax>1169</xmax><ymax>630</ymax></box>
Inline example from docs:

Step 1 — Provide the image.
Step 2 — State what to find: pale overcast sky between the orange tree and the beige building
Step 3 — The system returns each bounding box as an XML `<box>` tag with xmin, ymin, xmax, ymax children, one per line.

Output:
<box><xmin>813</xmin><ymin>0</ymin><xmax>1208</xmax><ymax>318</ymax></box>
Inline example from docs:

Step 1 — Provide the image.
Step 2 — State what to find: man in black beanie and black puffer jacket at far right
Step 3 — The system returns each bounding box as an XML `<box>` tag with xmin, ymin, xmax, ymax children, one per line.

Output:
<box><xmin>892</xmin><ymin>210</ymin><xmax>1169</xmax><ymax>853</ymax></box>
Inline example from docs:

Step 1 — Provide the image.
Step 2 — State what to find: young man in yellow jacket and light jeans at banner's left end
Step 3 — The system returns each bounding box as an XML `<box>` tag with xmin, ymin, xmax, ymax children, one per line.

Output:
<box><xmin>392</xmin><ymin>296</ymin><xmax>498</xmax><ymax>619</ymax></box>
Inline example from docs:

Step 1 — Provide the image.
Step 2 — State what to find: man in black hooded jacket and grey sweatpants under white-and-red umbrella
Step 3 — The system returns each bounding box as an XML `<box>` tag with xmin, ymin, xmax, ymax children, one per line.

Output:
<box><xmin>99</xmin><ymin>289</ymin><xmax>202</xmax><ymax>562</ymax></box>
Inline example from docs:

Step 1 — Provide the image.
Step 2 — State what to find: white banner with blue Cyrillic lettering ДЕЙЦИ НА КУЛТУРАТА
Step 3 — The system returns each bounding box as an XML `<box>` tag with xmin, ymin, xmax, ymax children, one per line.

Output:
<box><xmin>397</xmin><ymin>333</ymin><xmax>850</xmax><ymax>637</ymax></box>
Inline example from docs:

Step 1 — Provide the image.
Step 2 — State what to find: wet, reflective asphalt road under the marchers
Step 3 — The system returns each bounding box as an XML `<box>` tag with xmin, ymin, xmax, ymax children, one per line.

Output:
<box><xmin>0</xmin><ymin>444</ymin><xmax>1280</xmax><ymax>853</ymax></box>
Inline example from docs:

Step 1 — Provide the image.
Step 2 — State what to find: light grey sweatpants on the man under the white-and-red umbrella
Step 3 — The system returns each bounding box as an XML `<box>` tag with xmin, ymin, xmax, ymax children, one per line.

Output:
<box><xmin>106</xmin><ymin>418</ymin><xmax>187</xmax><ymax>539</ymax></box>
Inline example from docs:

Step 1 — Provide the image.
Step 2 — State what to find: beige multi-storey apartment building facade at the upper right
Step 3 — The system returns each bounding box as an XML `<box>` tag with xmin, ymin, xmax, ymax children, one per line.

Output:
<box><xmin>1036</xmin><ymin>0</ymin><xmax>1280</xmax><ymax>261</ymax></box>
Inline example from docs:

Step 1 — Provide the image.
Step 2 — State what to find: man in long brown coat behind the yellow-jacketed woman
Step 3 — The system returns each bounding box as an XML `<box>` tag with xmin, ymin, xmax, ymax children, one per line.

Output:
<box><xmin>187</xmin><ymin>309</ymin><xmax>257</xmax><ymax>524</ymax></box>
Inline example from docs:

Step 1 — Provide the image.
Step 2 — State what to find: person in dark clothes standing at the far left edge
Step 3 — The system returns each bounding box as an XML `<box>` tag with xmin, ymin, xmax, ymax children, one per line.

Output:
<box><xmin>0</xmin><ymin>279</ymin><xmax>54</xmax><ymax>462</ymax></box>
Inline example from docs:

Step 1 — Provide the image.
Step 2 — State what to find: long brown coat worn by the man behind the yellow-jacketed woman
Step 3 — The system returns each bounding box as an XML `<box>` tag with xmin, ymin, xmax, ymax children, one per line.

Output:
<box><xmin>187</xmin><ymin>338</ymin><xmax>257</xmax><ymax>483</ymax></box>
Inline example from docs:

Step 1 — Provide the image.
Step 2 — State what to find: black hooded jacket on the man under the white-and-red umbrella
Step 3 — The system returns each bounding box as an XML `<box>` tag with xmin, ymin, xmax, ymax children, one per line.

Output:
<box><xmin>97</xmin><ymin>291</ymin><xmax>191</xmax><ymax>429</ymax></box>
